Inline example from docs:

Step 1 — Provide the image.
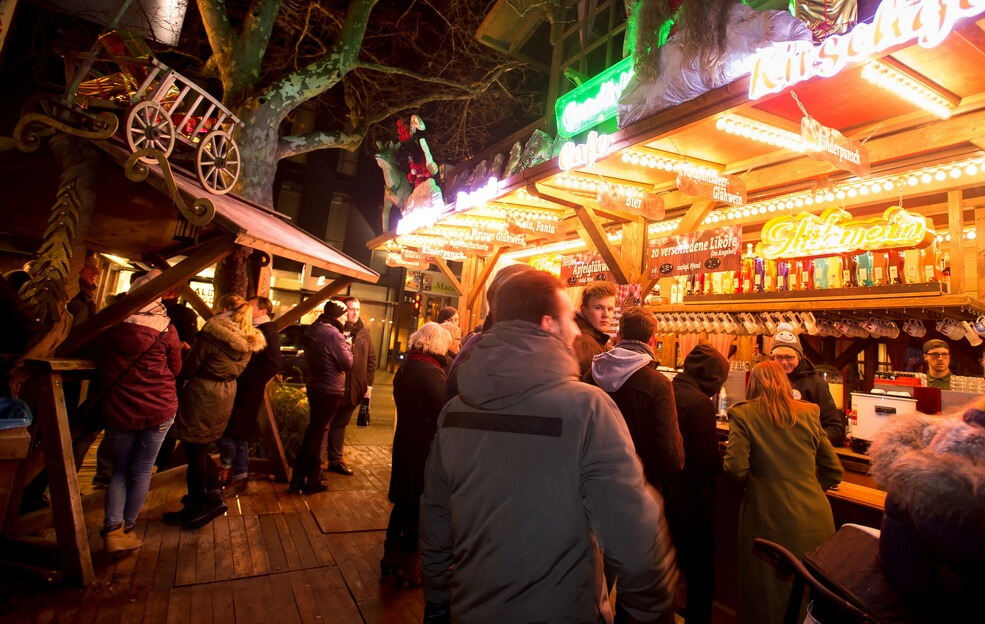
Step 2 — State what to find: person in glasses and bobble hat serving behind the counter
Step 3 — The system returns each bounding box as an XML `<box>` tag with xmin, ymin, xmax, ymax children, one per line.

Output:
<box><xmin>770</xmin><ymin>323</ymin><xmax>848</xmax><ymax>446</ymax></box>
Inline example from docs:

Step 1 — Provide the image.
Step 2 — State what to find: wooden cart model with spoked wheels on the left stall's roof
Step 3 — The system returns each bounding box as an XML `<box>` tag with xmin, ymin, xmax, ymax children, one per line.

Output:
<box><xmin>66</xmin><ymin>29</ymin><xmax>243</xmax><ymax>195</ymax></box>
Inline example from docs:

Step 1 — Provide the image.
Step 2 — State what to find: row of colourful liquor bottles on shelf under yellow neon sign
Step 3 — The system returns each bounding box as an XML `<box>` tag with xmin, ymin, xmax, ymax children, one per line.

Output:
<box><xmin>661</xmin><ymin>244</ymin><xmax>950</xmax><ymax>305</ymax></box>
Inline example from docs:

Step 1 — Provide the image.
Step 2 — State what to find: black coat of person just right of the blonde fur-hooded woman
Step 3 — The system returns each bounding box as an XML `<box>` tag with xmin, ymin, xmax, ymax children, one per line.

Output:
<box><xmin>225</xmin><ymin>316</ymin><xmax>282</xmax><ymax>440</ymax></box>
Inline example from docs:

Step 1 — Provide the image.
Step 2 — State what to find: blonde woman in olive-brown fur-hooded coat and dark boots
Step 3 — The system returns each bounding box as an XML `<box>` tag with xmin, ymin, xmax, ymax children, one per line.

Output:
<box><xmin>164</xmin><ymin>295</ymin><xmax>267</xmax><ymax>529</ymax></box>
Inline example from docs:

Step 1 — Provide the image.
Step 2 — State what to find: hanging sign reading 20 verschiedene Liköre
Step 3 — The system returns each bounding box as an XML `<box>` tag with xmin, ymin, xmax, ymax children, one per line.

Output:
<box><xmin>646</xmin><ymin>225</ymin><xmax>742</xmax><ymax>278</ymax></box>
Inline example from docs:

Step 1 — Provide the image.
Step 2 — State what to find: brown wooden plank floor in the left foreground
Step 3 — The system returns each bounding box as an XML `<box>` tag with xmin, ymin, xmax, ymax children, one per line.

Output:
<box><xmin>0</xmin><ymin>446</ymin><xmax>423</xmax><ymax>624</ymax></box>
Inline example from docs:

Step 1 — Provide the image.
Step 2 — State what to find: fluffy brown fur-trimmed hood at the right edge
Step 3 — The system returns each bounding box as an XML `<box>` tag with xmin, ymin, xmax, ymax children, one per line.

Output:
<box><xmin>869</xmin><ymin>415</ymin><xmax>985</xmax><ymax>530</ymax></box>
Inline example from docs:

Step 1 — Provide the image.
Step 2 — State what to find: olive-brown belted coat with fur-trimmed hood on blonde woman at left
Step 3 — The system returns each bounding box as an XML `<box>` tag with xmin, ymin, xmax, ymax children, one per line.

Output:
<box><xmin>174</xmin><ymin>313</ymin><xmax>267</xmax><ymax>444</ymax></box>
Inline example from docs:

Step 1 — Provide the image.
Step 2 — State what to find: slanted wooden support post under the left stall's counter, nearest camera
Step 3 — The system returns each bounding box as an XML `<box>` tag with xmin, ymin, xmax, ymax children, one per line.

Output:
<box><xmin>35</xmin><ymin>373</ymin><xmax>95</xmax><ymax>585</ymax></box>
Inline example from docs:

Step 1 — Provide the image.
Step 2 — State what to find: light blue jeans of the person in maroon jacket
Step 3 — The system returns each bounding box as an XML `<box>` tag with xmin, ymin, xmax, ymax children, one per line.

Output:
<box><xmin>104</xmin><ymin>418</ymin><xmax>174</xmax><ymax>529</ymax></box>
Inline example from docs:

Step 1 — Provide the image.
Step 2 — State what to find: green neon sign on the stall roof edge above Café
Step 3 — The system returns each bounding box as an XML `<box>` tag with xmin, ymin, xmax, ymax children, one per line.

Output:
<box><xmin>554</xmin><ymin>56</ymin><xmax>633</xmax><ymax>139</ymax></box>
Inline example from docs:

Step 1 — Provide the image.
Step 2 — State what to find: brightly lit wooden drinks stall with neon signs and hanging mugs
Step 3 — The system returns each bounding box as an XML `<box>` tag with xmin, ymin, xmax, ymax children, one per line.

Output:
<box><xmin>370</xmin><ymin>2</ymin><xmax>985</xmax><ymax>620</ymax></box>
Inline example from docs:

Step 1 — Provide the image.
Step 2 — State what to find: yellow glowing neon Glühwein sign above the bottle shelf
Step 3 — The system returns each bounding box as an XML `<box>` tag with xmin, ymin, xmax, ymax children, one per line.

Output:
<box><xmin>756</xmin><ymin>206</ymin><xmax>934</xmax><ymax>260</ymax></box>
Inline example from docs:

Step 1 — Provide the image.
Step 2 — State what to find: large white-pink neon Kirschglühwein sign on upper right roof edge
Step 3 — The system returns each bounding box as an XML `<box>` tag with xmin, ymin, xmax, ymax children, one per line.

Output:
<box><xmin>749</xmin><ymin>0</ymin><xmax>985</xmax><ymax>100</ymax></box>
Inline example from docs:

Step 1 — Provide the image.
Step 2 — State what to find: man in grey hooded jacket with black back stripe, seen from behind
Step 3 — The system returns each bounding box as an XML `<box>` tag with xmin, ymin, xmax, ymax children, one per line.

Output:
<box><xmin>420</xmin><ymin>271</ymin><xmax>677</xmax><ymax>624</ymax></box>
